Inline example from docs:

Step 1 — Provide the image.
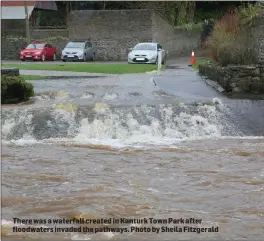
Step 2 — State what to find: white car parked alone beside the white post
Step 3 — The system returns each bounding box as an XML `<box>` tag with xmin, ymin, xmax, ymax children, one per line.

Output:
<box><xmin>128</xmin><ymin>43</ymin><xmax>166</xmax><ymax>64</ymax></box>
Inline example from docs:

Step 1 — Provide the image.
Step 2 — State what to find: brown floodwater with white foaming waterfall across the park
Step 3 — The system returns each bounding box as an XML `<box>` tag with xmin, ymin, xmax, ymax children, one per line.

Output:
<box><xmin>1</xmin><ymin>69</ymin><xmax>264</xmax><ymax>240</ymax></box>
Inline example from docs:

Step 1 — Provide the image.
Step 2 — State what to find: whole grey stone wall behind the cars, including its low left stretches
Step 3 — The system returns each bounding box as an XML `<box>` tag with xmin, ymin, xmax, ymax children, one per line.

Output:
<box><xmin>1</xmin><ymin>9</ymin><xmax>200</xmax><ymax>60</ymax></box>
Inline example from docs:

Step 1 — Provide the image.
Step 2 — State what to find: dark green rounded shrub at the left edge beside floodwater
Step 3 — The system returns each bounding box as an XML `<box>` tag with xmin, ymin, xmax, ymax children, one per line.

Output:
<box><xmin>1</xmin><ymin>75</ymin><xmax>34</xmax><ymax>104</ymax></box>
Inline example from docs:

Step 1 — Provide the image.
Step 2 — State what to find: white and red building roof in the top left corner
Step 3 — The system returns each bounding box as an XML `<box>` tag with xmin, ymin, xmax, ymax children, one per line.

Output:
<box><xmin>1</xmin><ymin>0</ymin><xmax>57</xmax><ymax>19</ymax></box>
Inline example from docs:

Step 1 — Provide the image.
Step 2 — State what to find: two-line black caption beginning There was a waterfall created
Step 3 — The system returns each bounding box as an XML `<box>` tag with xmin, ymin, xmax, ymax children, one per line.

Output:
<box><xmin>13</xmin><ymin>218</ymin><xmax>219</xmax><ymax>233</ymax></box>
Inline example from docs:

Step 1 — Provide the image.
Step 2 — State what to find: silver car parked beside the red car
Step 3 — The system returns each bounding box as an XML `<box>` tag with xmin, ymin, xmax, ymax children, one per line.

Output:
<box><xmin>61</xmin><ymin>41</ymin><xmax>95</xmax><ymax>62</ymax></box>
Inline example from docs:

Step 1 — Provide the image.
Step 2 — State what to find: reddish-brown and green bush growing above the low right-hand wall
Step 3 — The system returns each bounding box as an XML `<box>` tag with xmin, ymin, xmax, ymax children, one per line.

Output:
<box><xmin>207</xmin><ymin>7</ymin><xmax>258</xmax><ymax>66</ymax></box>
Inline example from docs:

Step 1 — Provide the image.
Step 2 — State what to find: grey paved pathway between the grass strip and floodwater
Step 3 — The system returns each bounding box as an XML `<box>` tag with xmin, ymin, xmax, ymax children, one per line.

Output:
<box><xmin>17</xmin><ymin>58</ymin><xmax>222</xmax><ymax>104</ymax></box>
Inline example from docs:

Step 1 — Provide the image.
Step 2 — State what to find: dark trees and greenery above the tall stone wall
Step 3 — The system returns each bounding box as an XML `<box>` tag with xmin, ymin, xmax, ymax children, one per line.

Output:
<box><xmin>32</xmin><ymin>1</ymin><xmax>257</xmax><ymax>27</ymax></box>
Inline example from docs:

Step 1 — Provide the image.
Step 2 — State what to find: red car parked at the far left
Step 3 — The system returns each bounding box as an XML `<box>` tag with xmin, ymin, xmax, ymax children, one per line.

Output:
<box><xmin>20</xmin><ymin>42</ymin><xmax>56</xmax><ymax>61</ymax></box>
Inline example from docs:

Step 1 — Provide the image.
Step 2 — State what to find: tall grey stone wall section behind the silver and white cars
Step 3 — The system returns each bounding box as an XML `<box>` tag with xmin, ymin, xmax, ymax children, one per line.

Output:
<box><xmin>68</xmin><ymin>10</ymin><xmax>201</xmax><ymax>60</ymax></box>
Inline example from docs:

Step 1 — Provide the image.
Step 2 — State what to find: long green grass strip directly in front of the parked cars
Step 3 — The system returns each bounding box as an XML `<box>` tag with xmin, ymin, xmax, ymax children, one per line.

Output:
<box><xmin>2</xmin><ymin>63</ymin><xmax>163</xmax><ymax>74</ymax></box>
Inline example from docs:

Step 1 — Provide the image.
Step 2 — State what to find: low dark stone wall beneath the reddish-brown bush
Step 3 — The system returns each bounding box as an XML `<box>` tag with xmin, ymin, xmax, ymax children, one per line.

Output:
<box><xmin>199</xmin><ymin>65</ymin><xmax>264</xmax><ymax>93</ymax></box>
